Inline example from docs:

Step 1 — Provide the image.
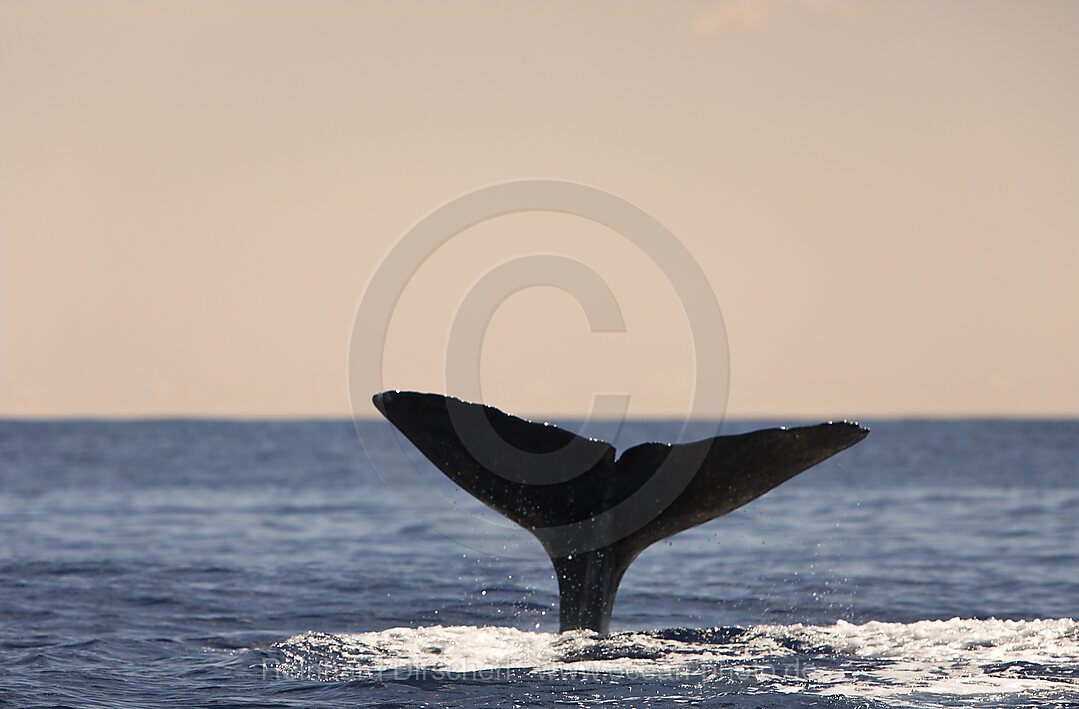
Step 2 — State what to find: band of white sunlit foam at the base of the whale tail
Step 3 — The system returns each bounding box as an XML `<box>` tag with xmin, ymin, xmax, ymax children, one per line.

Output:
<box><xmin>267</xmin><ymin>618</ymin><xmax>1079</xmax><ymax>706</ymax></box>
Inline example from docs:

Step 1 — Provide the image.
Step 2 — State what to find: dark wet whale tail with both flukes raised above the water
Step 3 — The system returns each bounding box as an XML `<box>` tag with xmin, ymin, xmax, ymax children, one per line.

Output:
<box><xmin>373</xmin><ymin>391</ymin><xmax>869</xmax><ymax>633</ymax></box>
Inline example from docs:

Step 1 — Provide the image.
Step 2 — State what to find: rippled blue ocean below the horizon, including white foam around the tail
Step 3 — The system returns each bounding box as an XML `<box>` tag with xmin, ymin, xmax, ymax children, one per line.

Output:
<box><xmin>0</xmin><ymin>420</ymin><xmax>1079</xmax><ymax>708</ymax></box>
